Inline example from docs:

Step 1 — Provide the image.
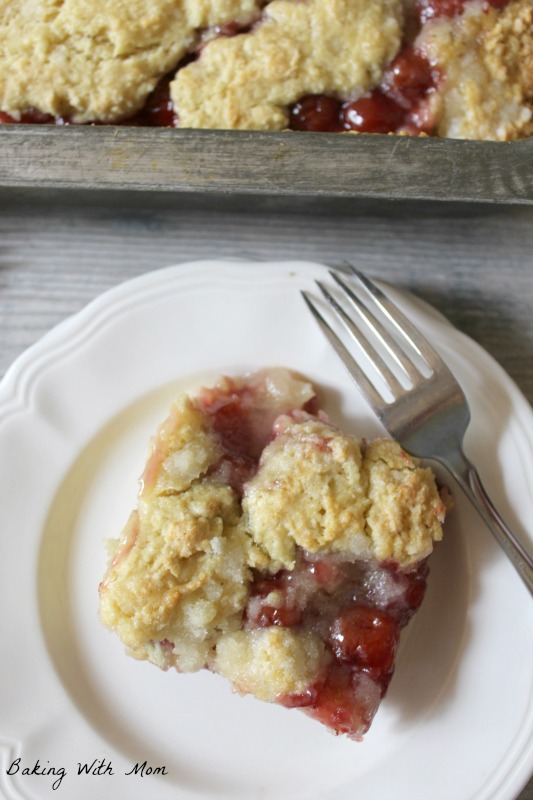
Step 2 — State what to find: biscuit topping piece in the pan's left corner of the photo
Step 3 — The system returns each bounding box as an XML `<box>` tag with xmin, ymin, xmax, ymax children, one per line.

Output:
<box><xmin>0</xmin><ymin>0</ymin><xmax>264</xmax><ymax>122</ymax></box>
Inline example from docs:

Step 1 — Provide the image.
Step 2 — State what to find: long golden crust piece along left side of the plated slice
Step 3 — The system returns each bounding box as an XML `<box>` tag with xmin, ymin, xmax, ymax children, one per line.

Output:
<box><xmin>100</xmin><ymin>398</ymin><xmax>253</xmax><ymax>670</ymax></box>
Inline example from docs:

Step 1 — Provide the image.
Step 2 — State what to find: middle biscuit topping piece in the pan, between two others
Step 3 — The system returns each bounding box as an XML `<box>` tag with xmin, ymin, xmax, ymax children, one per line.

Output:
<box><xmin>171</xmin><ymin>0</ymin><xmax>403</xmax><ymax>130</ymax></box>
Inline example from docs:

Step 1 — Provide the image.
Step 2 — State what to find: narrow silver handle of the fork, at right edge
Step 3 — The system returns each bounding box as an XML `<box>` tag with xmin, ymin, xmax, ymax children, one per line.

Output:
<box><xmin>460</xmin><ymin>464</ymin><xmax>533</xmax><ymax>595</ymax></box>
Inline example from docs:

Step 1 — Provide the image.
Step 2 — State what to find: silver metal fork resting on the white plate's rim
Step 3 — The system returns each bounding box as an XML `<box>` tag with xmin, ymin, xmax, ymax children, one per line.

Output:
<box><xmin>302</xmin><ymin>266</ymin><xmax>533</xmax><ymax>595</ymax></box>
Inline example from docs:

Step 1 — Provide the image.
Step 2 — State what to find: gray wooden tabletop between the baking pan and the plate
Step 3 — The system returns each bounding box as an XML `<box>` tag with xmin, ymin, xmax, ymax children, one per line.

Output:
<box><xmin>0</xmin><ymin>196</ymin><xmax>533</xmax><ymax>800</ymax></box>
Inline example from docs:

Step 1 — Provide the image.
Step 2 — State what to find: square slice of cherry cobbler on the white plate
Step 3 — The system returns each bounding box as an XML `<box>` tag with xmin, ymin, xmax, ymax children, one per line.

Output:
<box><xmin>100</xmin><ymin>369</ymin><xmax>445</xmax><ymax>739</ymax></box>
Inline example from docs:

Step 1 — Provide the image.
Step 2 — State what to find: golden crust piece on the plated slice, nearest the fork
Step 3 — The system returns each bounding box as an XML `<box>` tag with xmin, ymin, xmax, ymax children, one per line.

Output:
<box><xmin>243</xmin><ymin>419</ymin><xmax>445</xmax><ymax>570</ymax></box>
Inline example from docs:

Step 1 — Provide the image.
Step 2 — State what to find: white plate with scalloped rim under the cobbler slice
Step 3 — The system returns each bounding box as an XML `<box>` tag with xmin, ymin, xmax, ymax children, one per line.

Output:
<box><xmin>0</xmin><ymin>262</ymin><xmax>533</xmax><ymax>800</ymax></box>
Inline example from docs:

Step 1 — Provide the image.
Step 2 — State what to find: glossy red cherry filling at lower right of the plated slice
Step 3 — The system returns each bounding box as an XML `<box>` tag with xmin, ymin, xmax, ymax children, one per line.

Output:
<box><xmin>245</xmin><ymin>551</ymin><xmax>428</xmax><ymax>738</ymax></box>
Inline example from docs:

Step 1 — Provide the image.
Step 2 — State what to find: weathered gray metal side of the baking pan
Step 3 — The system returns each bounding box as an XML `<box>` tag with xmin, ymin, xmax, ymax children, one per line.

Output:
<box><xmin>0</xmin><ymin>125</ymin><xmax>533</xmax><ymax>209</ymax></box>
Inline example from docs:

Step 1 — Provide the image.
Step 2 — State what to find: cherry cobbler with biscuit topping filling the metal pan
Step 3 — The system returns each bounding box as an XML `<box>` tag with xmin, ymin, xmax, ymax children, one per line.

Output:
<box><xmin>0</xmin><ymin>0</ymin><xmax>533</xmax><ymax>141</ymax></box>
